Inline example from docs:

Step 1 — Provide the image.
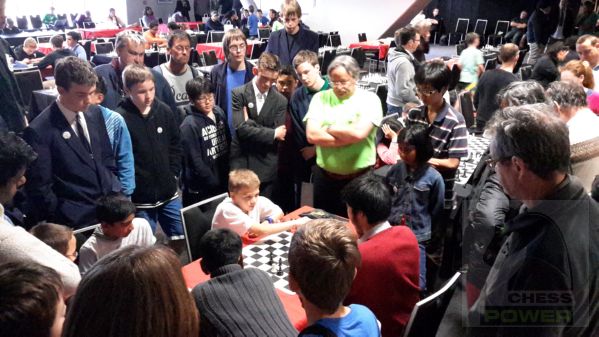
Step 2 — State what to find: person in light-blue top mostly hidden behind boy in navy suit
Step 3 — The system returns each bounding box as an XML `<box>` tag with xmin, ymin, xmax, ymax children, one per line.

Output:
<box><xmin>90</xmin><ymin>76</ymin><xmax>135</xmax><ymax>197</ymax></box>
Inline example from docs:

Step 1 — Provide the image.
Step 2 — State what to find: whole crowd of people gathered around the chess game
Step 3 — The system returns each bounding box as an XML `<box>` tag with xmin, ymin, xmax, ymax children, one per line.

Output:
<box><xmin>0</xmin><ymin>0</ymin><xmax>599</xmax><ymax>337</ymax></box>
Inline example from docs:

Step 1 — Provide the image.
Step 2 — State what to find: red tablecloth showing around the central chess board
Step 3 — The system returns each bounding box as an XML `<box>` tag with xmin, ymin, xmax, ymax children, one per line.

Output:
<box><xmin>181</xmin><ymin>206</ymin><xmax>313</xmax><ymax>331</ymax></box>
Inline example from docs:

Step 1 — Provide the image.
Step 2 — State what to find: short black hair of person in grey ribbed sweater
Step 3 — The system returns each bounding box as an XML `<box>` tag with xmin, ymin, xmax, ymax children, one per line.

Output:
<box><xmin>199</xmin><ymin>228</ymin><xmax>242</xmax><ymax>274</ymax></box>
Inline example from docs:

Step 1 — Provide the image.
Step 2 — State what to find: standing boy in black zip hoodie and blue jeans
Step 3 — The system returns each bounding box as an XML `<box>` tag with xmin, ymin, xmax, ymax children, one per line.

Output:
<box><xmin>117</xmin><ymin>64</ymin><xmax>183</xmax><ymax>240</ymax></box>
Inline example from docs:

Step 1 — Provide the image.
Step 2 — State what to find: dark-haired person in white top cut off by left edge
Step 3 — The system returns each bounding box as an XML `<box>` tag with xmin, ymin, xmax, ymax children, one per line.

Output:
<box><xmin>0</xmin><ymin>132</ymin><xmax>81</xmax><ymax>298</ymax></box>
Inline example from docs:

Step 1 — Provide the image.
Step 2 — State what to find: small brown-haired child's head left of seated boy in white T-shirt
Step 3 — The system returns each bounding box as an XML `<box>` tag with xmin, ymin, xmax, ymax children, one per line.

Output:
<box><xmin>29</xmin><ymin>222</ymin><xmax>77</xmax><ymax>262</ymax></box>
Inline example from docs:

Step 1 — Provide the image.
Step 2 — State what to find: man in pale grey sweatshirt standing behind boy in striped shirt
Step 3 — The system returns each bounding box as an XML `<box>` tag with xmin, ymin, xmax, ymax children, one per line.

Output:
<box><xmin>387</xmin><ymin>26</ymin><xmax>420</xmax><ymax>114</ymax></box>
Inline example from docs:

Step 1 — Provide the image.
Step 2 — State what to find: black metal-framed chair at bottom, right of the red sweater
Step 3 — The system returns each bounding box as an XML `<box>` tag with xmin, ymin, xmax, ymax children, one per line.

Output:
<box><xmin>403</xmin><ymin>272</ymin><xmax>462</xmax><ymax>337</ymax></box>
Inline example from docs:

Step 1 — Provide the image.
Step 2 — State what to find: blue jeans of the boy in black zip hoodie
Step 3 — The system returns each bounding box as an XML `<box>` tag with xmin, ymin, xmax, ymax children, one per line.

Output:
<box><xmin>136</xmin><ymin>197</ymin><xmax>185</xmax><ymax>240</ymax></box>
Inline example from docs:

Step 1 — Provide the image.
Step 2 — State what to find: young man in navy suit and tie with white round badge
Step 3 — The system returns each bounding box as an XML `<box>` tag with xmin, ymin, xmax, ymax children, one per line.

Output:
<box><xmin>24</xmin><ymin>57</ymin><xmax>121</xmax><ymax>228</ymax></box>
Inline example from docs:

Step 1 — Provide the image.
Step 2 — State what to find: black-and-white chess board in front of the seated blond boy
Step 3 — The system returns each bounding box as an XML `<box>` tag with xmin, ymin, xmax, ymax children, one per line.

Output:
<box><xmin>242</xmin><ymin>232</ymin><xmax>294</xmax><ymax>294</ymax></box>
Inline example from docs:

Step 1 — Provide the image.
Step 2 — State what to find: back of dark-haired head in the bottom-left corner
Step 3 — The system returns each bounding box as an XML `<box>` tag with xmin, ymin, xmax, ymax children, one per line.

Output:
<box><xmin>0</xmin><ymin>260</ymin><xmax>66</xmax><ymax>337</ymax></box>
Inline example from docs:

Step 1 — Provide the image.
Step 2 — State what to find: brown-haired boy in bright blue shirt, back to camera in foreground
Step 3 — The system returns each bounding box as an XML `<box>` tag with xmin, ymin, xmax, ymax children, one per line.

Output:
<box><xmin>288</xmin><ymin>219</ymin><xmax>380</xmax><ymax>337</ymax></box>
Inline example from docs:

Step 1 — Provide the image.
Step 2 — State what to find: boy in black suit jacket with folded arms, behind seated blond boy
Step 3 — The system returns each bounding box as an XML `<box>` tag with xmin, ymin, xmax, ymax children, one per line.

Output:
<box><xmin>231</xmin><ymin>53</ymin><xmax>287</xmax><ymax>198</ymax></box>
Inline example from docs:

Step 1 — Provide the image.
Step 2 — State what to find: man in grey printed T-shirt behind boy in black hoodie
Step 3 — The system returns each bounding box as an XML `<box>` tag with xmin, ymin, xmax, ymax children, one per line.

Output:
<box><xmin>152</xmin><ymin>30</ymin><xmax>202</xmax><ymax>121</ymax></box>
